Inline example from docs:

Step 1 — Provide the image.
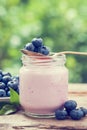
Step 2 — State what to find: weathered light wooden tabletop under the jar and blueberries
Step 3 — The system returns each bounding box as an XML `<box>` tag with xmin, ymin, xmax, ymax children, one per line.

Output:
<box><xmin>0</xmin><ymin>84</ymin><xmax>87</xmax><ymax>130</ymax></box>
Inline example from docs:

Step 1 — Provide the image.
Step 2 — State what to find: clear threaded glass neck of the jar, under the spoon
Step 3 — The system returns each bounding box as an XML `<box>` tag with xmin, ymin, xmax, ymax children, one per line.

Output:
<box><xmin>22</xmin><ymin>55</ymin><xmax>66</xmax><ymax>66</ymax></box>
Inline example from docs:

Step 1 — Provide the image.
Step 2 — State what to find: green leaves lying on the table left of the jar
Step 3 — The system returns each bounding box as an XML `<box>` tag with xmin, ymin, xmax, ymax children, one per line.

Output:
<box><xmin>0</xmin><ymin>88</ymin><xmax>19</xmax><ymax>115</ymax></box>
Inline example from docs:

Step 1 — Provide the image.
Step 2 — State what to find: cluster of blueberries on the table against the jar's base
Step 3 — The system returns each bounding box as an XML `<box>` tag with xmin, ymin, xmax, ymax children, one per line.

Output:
<box><xmin>55</xmin><ymin>100</ymin><xmax>87</xmax><ymax>120</ymax></box>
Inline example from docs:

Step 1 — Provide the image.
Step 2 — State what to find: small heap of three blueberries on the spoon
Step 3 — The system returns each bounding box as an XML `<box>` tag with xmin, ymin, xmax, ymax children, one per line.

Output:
<box><xmin>24</xmin><ymin>38</ymin><xmax>49</xmax><ymax>55</ymax></box>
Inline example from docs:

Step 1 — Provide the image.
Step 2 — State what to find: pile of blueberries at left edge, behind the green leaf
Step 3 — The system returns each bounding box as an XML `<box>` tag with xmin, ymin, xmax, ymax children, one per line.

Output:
<box><xmin>0</xmin><ymin>70</ymin><xmax>19</xmax><ymax>97</ymax></box>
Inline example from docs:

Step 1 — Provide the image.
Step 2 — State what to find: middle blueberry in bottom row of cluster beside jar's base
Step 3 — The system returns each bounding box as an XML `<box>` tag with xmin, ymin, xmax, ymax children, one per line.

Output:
<box><xmin>69</xmin><ymin>109</ymin><xmax>84</xmax><ymax>120</ymax></box>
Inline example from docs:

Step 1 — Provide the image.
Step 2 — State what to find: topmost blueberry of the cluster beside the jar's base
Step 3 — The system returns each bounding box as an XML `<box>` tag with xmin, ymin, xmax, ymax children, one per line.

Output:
<box><xmin>64</xmin><ymin>100</ymin><xmax>77</xmax><ymax>112</ymax></box>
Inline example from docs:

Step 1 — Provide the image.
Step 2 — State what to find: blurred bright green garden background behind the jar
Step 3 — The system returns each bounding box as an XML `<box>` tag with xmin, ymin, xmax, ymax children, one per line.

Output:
<box><xmin>0</xmin><ymin>0</ymin><xmax>87</xmax><ymax>83</ymax></box>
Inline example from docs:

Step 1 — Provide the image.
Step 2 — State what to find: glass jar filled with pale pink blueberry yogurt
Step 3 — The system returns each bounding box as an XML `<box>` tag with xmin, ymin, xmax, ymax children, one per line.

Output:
<box><xmin>19</xmin><ymin>55</ymin><xmax>68</xmax><ymax>118</ymax></box>
